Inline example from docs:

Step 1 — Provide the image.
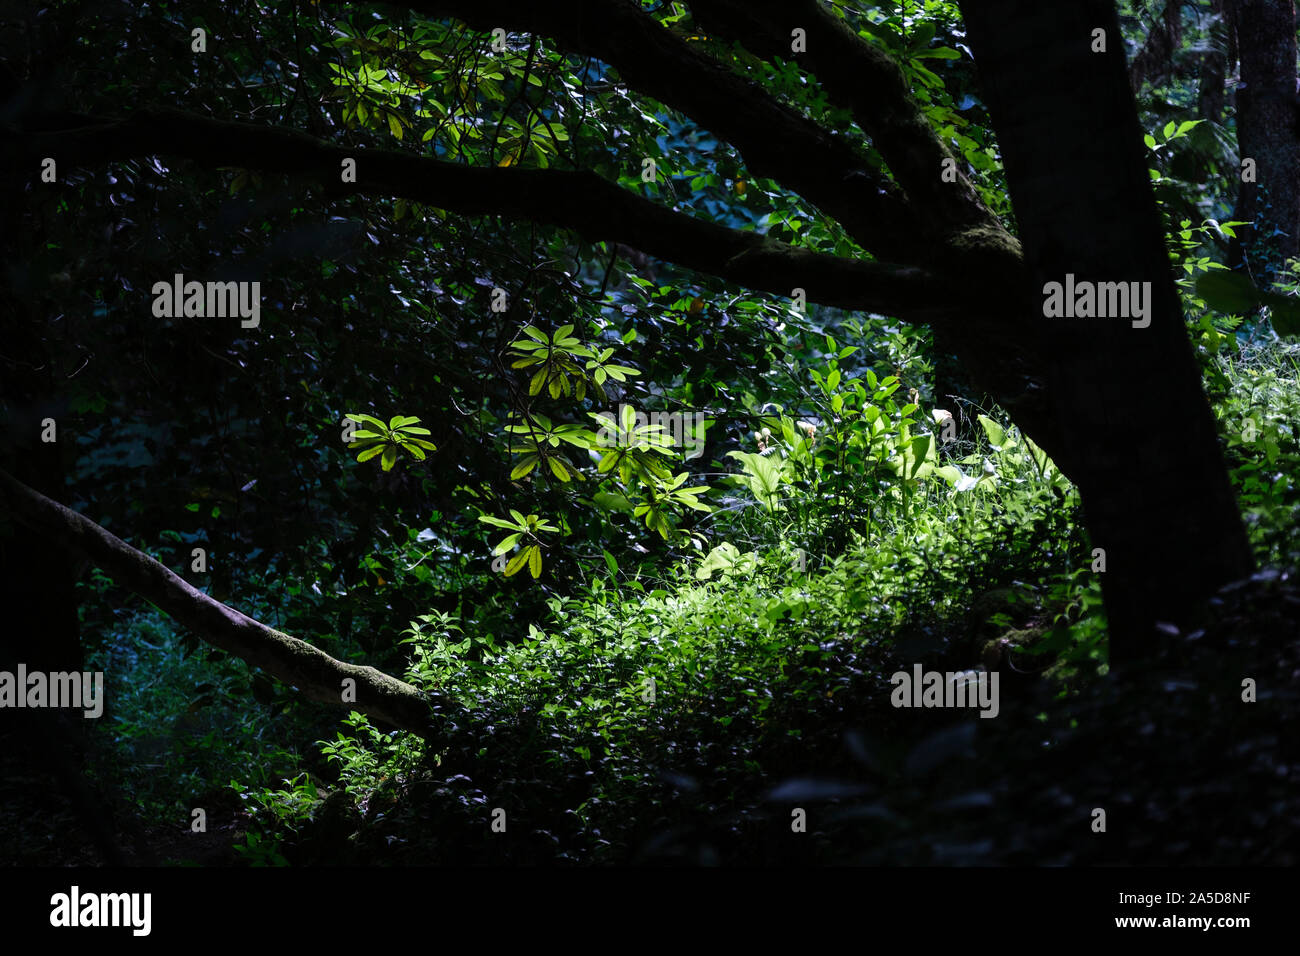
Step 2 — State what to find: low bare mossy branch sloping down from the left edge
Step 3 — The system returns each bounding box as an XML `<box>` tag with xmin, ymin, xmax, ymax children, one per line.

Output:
<box><xmin>0</xmin><ymin>470</ymin><xmax>446</xmax><ymax>735</ymax></box>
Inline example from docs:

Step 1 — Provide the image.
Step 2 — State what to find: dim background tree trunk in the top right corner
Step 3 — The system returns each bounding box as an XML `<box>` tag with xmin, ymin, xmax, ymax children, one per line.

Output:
<box><xmin>1231</xmin><ymin>0</ymin><xmax>1300</xmax><ymax>287</ymax></box>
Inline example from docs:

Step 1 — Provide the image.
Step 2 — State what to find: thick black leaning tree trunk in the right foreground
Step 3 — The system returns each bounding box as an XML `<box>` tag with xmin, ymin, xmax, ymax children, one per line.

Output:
<box><xmin>962</xmin><ymin>0</ymin><xmax>1252</xmax><ymax>663</ymax></box>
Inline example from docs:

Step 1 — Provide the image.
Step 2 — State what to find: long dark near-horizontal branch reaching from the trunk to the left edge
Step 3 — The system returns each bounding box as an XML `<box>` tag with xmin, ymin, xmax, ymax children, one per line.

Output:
<box><xmin>9</xmin><ymin>109</ymin><xmax>963</xmax><ymax>321</ymax></box>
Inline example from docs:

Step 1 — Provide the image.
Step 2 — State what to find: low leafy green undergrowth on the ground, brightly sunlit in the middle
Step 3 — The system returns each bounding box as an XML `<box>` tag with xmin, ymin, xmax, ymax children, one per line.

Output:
<box><xmin>83</xmin><ymin>343</ymin><xmax>1300</xmax><ymax>864</ymax></box>
